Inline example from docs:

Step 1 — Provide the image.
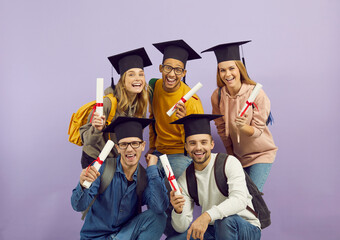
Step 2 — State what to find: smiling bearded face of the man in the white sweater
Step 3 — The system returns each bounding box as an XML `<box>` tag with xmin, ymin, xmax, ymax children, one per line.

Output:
<box><xmin>185</xmin><ymin>134</ymin><xmax>215</xmax><ymax>170</ymax></box>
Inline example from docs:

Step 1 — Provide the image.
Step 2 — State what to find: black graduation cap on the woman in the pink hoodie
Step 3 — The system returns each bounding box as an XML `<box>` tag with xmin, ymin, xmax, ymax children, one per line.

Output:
<box><xmin>201</xmin><ymin>40</ymin><xmax>251</xmax><ymax>63</ymax></box>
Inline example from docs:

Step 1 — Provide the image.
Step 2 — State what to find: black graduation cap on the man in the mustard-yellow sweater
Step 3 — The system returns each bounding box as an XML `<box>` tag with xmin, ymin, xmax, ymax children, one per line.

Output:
<box><xmin>152</xmin><ymin>39</ymin><xmax>201</xmax><ymax>67</ymax></box>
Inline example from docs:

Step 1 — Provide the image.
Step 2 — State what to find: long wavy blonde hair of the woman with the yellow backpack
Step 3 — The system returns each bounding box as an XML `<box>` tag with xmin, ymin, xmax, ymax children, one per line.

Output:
<box><xmin>114</xmin><ymin>72</ymin><xmax>148</xmax><ymax>118</ymax></box>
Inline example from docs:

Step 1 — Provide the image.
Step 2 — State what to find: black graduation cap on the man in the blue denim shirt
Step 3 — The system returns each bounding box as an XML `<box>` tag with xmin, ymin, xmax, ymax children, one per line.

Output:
<box><xmin>104</xmin><ymin>117</ymin><xmax>154</xmax><ymax>142</ymax></box>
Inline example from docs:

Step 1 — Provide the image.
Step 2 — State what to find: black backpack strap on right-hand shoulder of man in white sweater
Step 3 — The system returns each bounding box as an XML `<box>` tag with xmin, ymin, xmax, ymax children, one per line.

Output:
<box><xmin>214</xmin><ymin>153</ymin><xmax>229</xmax><ymax>197</ymax></box>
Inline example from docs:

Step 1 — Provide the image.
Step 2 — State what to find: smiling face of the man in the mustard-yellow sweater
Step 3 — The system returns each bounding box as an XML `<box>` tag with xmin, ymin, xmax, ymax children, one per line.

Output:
<box><xmin>159</xmin><ymin>58</ymin><xmax>186</xmax><ymax>92</ymax></box>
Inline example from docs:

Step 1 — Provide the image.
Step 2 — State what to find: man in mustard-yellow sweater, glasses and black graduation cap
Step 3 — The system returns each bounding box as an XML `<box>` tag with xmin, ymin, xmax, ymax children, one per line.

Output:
<box><xmin>148</xmin><ymin>40</ymin><xmax>203</xmax><ymax>178</ymax></box>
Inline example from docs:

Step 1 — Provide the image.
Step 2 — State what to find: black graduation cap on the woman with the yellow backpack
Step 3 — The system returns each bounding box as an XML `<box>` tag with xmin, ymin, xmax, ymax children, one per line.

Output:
<box><xmin>108</xmin><ymin>48</ymin><xmax>152</xmax><ymax>75</ymax></box>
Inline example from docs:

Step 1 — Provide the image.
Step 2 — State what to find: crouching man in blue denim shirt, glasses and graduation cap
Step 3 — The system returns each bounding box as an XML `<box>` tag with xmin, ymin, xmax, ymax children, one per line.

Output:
<box><xmin>71</xmin><ymin>117</ymin><xmax>169</xmax><ymax>239</ymax></box>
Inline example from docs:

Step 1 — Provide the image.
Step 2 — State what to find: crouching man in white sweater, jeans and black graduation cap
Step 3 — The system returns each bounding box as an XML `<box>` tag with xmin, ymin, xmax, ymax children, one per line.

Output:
<box><xmin>169</xmin><ymin>114</ymin><xmax>261</xmax><ymax>240</ymax></box>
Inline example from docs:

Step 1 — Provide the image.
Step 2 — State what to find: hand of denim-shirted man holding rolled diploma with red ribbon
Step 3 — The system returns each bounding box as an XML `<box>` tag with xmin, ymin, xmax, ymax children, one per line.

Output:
<box><xmin>80</xmin><ymin>140</ymin><xmax>115</xmax><ymax>188</ymax></box>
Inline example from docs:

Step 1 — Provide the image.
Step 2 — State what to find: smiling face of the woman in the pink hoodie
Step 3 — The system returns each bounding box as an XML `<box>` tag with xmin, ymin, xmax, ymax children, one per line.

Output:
<box><xmin>218</xmin><ymin>61</ymin><xmax>241</xmax><ymax>92</ymax></box>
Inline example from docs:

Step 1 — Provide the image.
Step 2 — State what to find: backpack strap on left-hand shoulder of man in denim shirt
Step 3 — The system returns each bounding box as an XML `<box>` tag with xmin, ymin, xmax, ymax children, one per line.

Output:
<box><xmin>81</xmin><ymin>158</ymin><xmax>117</xmax><ymax>220</ymax></box>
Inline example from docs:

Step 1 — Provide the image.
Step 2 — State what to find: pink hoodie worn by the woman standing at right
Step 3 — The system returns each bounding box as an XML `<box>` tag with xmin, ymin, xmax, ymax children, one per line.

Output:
<box><xmin>211</xmin><ymin>83</ymin><xmax>277</xmax><ymax>167</ymax></box>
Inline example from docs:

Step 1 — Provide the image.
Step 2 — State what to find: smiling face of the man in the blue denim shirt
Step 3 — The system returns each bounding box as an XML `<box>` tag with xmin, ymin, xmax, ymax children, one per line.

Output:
<box><xmin>116</xmin><ymin>137</ymin><xmax>145</xmax><ymax>168</ymax></box>
